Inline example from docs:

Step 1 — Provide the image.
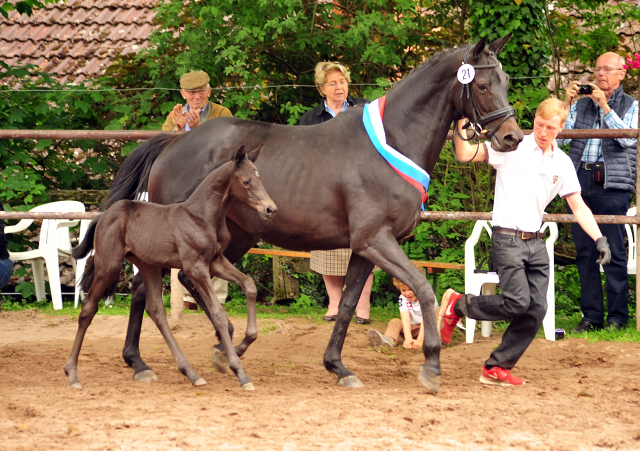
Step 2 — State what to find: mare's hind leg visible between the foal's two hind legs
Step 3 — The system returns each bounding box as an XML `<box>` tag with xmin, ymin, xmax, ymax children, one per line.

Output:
<box><xmin>122</xmin><ymin>273</ymin><xmax>158</xmax><ymax>382</ymax></box>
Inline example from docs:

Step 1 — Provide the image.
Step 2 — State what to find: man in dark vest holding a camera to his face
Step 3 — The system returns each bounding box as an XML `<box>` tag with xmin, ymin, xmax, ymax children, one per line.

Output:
<box><xmin>559</xmin><ymin>52</ymin><xmax>638</xmax><ymax>332</ymax></box>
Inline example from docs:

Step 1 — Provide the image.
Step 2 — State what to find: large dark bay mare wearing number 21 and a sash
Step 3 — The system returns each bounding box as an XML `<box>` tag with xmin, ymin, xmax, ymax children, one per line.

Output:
<box><xmin>103</xmin><ymin>36</ymin><xmax>523</xmax><ymax>393</ymax></box>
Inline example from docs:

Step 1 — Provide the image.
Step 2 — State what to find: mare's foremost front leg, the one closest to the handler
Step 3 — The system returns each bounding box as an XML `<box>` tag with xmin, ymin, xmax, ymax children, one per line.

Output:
<box><xmin>352</xmin><ymin>236</ymin><xmax>442</xmax><ymax>393</ymax></box>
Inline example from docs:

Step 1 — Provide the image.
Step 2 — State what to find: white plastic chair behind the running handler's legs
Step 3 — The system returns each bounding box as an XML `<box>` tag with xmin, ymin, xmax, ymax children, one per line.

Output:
<box><xmin>464</xmin><ymin>221</ymin><xmax>558</xmax><ymax>343</ymax></box>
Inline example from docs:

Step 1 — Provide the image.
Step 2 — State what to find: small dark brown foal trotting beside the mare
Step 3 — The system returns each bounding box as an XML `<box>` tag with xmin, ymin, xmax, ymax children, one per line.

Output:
<box><xmin>64</xmin><ymin>146</ymin><xmax>276</xmax><ymax>390</ymax></box>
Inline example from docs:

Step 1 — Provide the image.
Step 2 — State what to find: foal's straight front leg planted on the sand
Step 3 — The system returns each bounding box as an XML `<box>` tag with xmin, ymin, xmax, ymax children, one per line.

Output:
<box><xmin>185</xmin><ymin>262</ymin><xmax>254</xmax><ymax>390</ymax></box>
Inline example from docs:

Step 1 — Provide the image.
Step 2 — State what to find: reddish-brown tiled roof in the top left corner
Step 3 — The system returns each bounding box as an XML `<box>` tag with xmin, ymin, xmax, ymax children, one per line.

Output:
<box><xmin>0</xmin><ymin>0</ymin><xmax>161</xmax><ymax>83</ymax></box>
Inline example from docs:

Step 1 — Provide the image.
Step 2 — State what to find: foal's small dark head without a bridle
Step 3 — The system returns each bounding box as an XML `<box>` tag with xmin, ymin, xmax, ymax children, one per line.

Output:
<box><xmin>231</xmin><ymin>145</ymin><xmax>278</xmax><ymax>219</ymax></box>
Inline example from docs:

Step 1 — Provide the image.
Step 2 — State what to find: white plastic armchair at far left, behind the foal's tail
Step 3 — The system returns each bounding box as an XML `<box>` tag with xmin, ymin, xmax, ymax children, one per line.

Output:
<box><xmin>5</xmin><ymin>200</ymin><xmax>85</xmax><ymax>310</ymax></box>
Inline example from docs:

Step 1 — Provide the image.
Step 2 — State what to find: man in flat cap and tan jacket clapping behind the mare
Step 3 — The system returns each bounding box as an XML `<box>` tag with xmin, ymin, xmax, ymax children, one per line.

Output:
<box><xmin>162</xmin><ymin>70</ymin><xmax>233</xmax><ymax>310</ymax></box>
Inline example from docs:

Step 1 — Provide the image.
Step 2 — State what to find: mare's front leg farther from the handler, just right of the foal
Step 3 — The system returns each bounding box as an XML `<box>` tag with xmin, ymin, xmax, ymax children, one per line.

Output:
<box><xmin>323</xmin><ymin>253</ymin><xmax>373</xmax><ymax>388</ymax></box>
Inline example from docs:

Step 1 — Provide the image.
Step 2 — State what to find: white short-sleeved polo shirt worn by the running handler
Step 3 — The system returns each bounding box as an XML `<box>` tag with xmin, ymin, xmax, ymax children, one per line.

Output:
<box><xmin>487</xmin><ymin>133</ymin><xmax>581</xmax><ymax>232</ymax></box>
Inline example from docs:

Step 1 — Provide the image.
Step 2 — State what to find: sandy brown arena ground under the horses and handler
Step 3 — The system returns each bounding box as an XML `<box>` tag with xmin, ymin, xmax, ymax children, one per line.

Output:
<box><xmin>0</xmin><ymin>311</ymin><xmax>640</xmax><ymax>451</ymax></box>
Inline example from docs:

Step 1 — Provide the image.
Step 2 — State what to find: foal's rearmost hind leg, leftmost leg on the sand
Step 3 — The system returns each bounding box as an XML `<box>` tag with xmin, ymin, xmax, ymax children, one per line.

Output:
<box><xmin>64</xmin><ymin>256</ymin><xmax>124</xmax><ymax>388</ymax></box>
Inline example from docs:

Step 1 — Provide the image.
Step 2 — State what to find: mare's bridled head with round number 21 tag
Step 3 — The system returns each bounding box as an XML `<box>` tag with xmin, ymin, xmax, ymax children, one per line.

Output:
<box><xmin>454</xmin><ymin>34</ymin><xmax>523</xmax><ymax>152</ymax></box>
